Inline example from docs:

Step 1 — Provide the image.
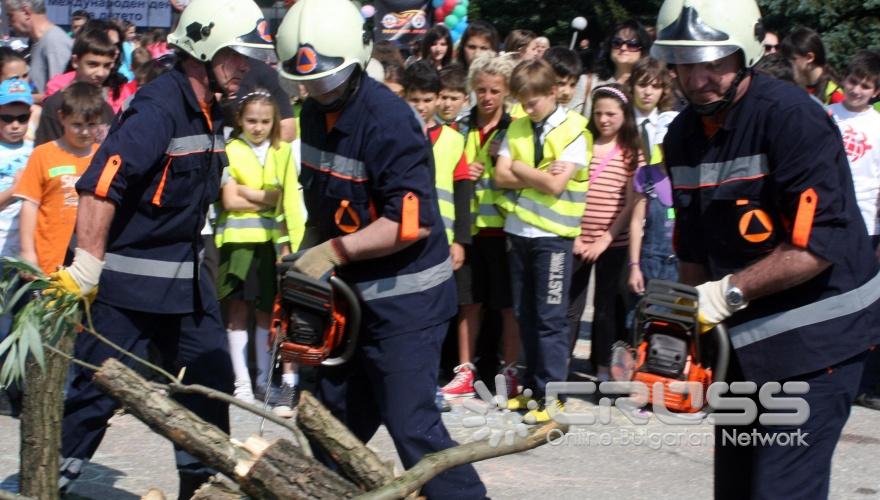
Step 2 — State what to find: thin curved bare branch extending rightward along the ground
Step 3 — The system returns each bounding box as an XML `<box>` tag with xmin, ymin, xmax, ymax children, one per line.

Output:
<box><xmin>356</xmin><ymin>422</ymin><xmax>568</xmax><ymax>500</ymax></box>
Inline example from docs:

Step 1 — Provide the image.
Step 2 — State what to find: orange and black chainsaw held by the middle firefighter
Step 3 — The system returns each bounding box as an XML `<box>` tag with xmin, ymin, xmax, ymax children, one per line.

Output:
<box><xmin>270</xmin><ymin>254</ymin><xmax>361</xmax><ymax>366</ymax></box>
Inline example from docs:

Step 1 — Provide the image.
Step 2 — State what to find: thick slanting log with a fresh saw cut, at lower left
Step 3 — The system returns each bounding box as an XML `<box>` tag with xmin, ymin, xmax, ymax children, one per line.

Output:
<box><xmin>95</xmin><ymin>358</ymin><xmax>359</xmax><ymax>499</ymax></box>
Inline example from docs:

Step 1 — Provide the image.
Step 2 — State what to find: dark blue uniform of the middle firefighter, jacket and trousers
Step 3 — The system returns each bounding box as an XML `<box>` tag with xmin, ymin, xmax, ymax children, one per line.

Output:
<box><xmin>300</xmin><ymin>77</ymin><xmax>486</xmax><ymax>498</ymax></box>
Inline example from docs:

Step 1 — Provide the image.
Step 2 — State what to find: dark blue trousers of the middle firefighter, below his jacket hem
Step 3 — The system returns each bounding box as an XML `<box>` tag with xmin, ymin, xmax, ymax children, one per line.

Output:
<box><xmin>318</xmin><ymin>323</ymin><xmax>486</xmax><ymax>499</ymax></box>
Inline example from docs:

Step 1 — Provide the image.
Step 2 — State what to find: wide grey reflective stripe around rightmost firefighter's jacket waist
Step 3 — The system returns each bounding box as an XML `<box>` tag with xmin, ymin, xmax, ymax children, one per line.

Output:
<box><xmin>730</xmin><ymin>273</ymin><xmax>880</xmax><ymax>349</ymax></box>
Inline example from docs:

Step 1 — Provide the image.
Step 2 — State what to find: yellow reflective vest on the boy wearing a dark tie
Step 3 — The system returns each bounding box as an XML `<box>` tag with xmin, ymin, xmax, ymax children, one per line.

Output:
<box><xmin>498</xmin><ymin>111</ymin><xmax>593</xmax><ymax>238</ymax></box>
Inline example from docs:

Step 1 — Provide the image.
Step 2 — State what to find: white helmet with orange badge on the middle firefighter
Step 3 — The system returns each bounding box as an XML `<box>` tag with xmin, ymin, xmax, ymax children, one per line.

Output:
<box><xmin>276</xmin><ymin>0</ymin><xmax>373</xmax><ymax>94</ymax></box>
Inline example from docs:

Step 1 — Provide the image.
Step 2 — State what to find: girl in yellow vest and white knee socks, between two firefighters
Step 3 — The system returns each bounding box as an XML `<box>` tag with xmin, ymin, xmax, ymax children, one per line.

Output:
<box><xmin>215</xmin><ymin>89</ymin><xmax>302</xmax><ymax>413</ymax></box>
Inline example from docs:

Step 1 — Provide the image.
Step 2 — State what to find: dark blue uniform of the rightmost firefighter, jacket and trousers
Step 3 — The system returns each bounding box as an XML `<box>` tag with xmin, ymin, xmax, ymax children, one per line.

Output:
<box><xmin>664</xmin><ymin>75</ymin><xmax>880</xmax><ymax>499</ymax></box>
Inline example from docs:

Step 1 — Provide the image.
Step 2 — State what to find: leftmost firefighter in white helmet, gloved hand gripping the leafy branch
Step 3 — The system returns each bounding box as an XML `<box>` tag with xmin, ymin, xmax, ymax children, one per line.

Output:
<box><xmin>48</xmin><ymin>0</ymin><xmax>274</xmax><ymax>498</ymax></box>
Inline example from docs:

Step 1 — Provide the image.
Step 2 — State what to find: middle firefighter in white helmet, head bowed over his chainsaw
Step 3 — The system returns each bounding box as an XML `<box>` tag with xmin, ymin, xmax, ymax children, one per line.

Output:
<box><xmin>276</xmin><ymin>0</ymin><xmax>486</xmax><ymax>499</ymax></box>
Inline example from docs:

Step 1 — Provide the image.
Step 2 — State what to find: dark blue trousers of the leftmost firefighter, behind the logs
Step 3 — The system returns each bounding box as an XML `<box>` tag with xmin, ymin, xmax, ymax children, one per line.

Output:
<box><xmin>61</xmin><ymin>301</ymin><xmax>233</xmax><ymax>478</ymax></box>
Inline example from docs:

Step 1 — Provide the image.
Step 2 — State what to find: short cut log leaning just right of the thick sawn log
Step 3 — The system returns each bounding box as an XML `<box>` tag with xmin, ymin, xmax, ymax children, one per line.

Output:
<box><xmin>296</xmin><ymin>391</ymin><xmax>394</xmax><ymax>491</ymax></box>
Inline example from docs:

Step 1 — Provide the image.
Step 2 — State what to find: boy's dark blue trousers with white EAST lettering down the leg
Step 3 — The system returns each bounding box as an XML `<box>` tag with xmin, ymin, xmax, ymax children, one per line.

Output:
<box><xmin>507</xmin><ymin>234</ymin><xmax>573</xmax><ymax>399</ymax></box>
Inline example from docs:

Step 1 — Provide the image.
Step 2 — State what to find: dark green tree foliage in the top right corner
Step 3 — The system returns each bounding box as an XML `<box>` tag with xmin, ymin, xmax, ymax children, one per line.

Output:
<box><xmin>758</xmin><ymin>0</ymin><xmax>880</xmax><ymax>70</ymax></box>
